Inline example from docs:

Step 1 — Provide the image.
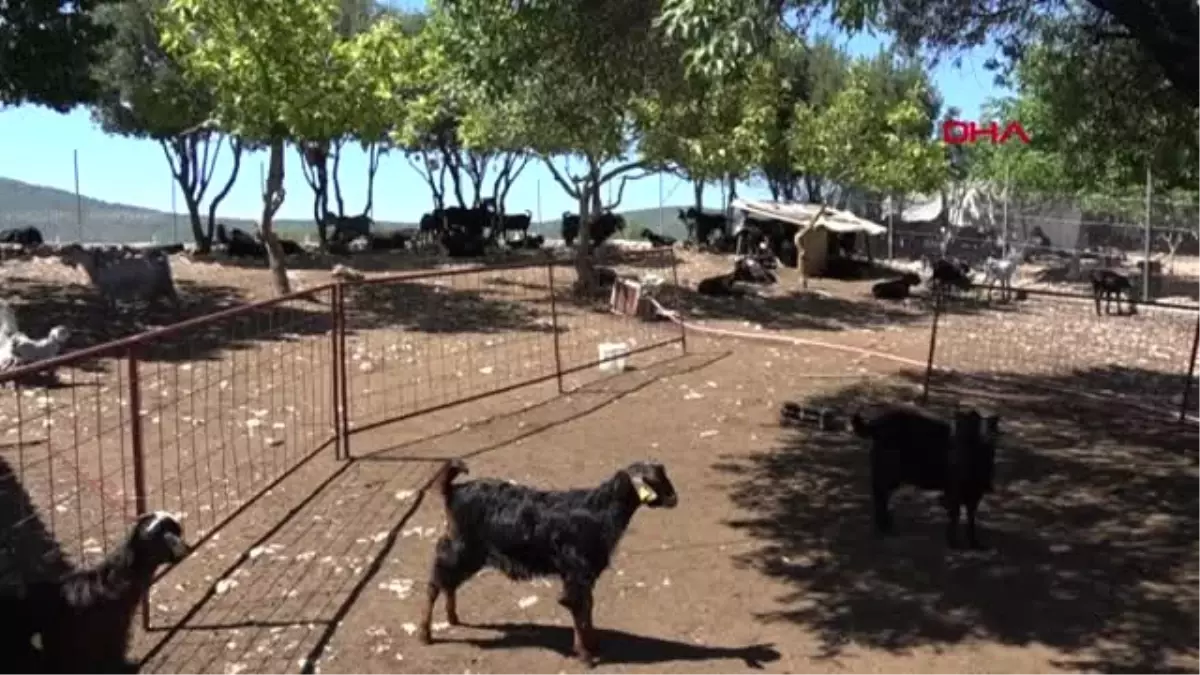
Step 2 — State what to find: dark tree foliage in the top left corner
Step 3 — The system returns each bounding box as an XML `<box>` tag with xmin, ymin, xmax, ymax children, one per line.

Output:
<box><xmin>0</xmin><ymin>0</ymin><xmax>108</xmax><ymax>112</ymax></box>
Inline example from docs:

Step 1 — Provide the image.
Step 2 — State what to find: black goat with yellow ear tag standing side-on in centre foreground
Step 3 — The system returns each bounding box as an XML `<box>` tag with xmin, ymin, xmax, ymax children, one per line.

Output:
<box><xmin>418</xmin><ymin>460</ymin><xmax>679</xmax><ymax>664</ymax></box>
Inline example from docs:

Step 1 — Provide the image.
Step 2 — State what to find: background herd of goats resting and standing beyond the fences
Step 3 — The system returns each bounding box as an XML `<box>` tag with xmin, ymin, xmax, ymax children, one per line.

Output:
<box><xmin>0</xmin><ymin>201</ymin><xmax>1136</xmax><ymax>379</ymax></box>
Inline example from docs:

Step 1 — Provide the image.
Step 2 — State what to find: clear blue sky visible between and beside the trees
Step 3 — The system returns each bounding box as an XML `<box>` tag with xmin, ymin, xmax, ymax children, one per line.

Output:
<box><xmin>0</xmin><ymin>24</ymin><xmax>1003</xmax><ymax>222</ymax></box>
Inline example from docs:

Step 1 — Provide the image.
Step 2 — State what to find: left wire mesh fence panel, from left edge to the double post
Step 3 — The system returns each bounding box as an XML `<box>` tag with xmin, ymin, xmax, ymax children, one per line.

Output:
<box><xmin>0</xmin><ymin>289</ymin><xmax>335</xmax><ymax>579</ymax></box>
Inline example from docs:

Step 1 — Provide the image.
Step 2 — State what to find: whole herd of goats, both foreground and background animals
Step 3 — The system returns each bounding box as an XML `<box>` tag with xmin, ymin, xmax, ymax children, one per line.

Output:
<box><xmin>0</xmin><ymin>194</ymin><xmax>1171</xmax><ymax>675</ymax></box>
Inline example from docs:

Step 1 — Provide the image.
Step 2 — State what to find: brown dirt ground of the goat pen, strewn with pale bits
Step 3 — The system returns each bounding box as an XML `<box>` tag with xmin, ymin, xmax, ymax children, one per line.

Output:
<box><xmin>0</xmin><ymin>243</ymin><xmax>1200</xmax><ymax>674</ymax></box>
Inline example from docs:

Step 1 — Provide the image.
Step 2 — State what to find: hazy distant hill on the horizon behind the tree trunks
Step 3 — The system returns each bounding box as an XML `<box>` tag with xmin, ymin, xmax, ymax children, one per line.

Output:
<box><xmin>0</xmin><ymin>178</ymin><xmax>705</xmax><ymax>244</ymax></box>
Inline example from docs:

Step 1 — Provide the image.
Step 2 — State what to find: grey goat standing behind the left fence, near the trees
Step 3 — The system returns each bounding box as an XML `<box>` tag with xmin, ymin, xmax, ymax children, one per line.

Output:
<box><xmin>61</xmin><ymin>246</ymin><xmax>179</xmax><ymax>310</ymax></box>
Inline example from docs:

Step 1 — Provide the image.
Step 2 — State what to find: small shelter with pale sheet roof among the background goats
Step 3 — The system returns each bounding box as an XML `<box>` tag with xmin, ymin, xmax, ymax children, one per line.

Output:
<box><xmin>731</xmin><ymin>199</ymin><xmax>888</xmax><ymax>276</ymax></box>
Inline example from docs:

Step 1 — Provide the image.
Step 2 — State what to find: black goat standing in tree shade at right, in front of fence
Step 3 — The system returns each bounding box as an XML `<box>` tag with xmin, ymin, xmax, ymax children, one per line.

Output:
<box><xmin>851</xmin><ymin>406</ymin><xmax>1000</xmax><ymax>548</ymax></box>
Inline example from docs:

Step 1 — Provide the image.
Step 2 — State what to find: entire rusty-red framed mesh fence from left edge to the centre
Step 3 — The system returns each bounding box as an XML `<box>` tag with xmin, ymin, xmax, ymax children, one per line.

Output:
<box><xmin>0</xmin><ymin>250</ymin><xmax>683</xmax><ymax>612</ymax></box>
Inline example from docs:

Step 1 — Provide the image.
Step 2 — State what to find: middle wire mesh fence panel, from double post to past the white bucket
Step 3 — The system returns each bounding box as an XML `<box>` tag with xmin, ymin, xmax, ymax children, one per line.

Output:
<box><xmin>344</xmin><ymin>251</ymin><xmax>679</xmax><ymax>441</ymax></box>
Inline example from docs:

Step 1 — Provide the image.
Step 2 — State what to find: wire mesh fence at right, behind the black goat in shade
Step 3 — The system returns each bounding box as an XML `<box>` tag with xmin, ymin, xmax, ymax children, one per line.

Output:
<box><xmin>926</xmin><ymin>291</ymin><xmax>1200</xmax><ymax>417</ymax></box>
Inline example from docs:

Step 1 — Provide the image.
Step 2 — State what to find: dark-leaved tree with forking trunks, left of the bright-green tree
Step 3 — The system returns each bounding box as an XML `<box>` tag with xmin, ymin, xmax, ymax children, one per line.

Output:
<box><xmin>92</xmin><ymin>0</ymin><xmax>242</xmax><ymax>252</ymax></box>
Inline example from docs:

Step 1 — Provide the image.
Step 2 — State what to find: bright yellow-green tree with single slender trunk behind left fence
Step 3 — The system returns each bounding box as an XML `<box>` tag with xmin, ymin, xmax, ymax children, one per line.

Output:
<box><xmin>160</xmin><ymin>0</ymin><xmax>408</xmax><ymax>293</ymax></box>
